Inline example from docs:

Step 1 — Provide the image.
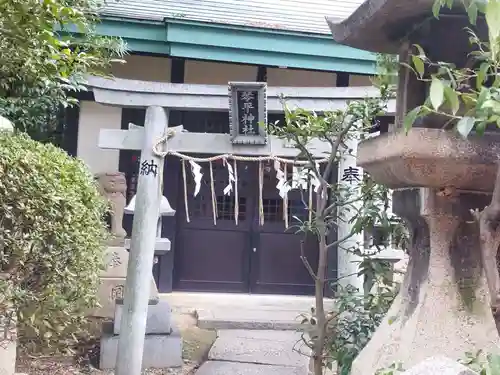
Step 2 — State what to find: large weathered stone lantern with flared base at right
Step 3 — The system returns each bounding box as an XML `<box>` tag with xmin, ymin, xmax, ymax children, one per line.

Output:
<box><xmin>327</xmin><ymin>0</ymin><xmax>500</xmax><ymax>375</ymax></box>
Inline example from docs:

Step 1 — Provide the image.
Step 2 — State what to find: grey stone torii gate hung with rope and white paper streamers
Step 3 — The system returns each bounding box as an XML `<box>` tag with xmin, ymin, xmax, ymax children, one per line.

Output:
<box><xmin>89</xmin><ymin>77</ymin><xmax>394</xmax><ymax>375</ymax></box>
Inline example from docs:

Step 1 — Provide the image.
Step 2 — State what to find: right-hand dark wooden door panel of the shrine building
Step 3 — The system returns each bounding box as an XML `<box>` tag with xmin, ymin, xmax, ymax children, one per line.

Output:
<box><xmin>250</xmin><ymin>163</ymin><xmax>318</xmax><ymax>295</ymax></box>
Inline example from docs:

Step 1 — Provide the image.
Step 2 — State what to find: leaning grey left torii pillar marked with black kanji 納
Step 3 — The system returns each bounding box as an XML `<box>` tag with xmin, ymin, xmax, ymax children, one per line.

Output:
<box><xmin>105</xmin><ymin>106</ymin><xmax>168</xmax><ymax>375</ymax></box>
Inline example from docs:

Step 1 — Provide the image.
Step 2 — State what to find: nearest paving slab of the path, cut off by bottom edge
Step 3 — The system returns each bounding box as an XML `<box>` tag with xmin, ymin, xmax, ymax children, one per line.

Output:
<box><xmin>196</xmin><ymin>361</ymin><xmax>307</xmax><ymax>375</ymax></box>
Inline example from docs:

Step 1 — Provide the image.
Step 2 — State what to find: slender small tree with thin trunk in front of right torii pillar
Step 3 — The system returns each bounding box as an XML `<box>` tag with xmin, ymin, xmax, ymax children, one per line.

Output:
<box><xmin>272</xmin><ymin>53</ymin><xmax>402</xmax><ymax>375</ymax></box>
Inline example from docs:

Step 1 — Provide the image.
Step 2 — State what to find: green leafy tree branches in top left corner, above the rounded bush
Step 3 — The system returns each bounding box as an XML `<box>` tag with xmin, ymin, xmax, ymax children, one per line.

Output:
<box><xmin>0</xmin><ymin>0</ymin><xmax>125</xmax><ymax>141</ymax></box>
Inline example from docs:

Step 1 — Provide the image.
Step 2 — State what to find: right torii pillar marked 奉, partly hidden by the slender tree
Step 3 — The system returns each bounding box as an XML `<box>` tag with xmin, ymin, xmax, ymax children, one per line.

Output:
<box><xmin>337</xmin><ymin>138</ymin><xmax>363</xmax><ymax>292</ymax></box>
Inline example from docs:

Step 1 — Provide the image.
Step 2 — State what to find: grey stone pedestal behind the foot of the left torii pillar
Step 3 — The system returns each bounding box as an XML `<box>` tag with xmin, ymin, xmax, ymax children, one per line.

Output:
<box><xmin>99</xmin><ymin>300</ymin><xmax>182</xmax><ymax>370</ymax></box>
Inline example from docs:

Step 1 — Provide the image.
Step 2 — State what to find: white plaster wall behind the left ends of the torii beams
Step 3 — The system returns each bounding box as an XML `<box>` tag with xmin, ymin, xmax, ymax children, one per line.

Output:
<box><xmin>77</xmin><ymin>101</ymin><xmax>122</xmax><ymax>173</ymax></box>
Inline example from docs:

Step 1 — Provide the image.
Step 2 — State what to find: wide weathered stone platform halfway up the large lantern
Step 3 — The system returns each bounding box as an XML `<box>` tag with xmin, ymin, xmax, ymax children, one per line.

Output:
<box><xmin>358</xmin><ymin>128</ymin><xmax>500</xmax><ymax>194</ymax></box>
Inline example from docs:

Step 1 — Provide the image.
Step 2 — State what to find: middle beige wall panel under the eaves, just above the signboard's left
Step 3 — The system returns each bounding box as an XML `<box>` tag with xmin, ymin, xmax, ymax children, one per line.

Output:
<box><xmin>184</xmin><ymin>60</ymin><xmax>257</xmax><ymax>85</ymax></box>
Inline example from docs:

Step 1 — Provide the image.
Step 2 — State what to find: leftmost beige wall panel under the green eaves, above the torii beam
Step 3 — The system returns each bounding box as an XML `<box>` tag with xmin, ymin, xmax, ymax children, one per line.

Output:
<box><xmin>111</xmin><ymin>55</ymin><xmax>172</xmax><ymax>82</ymax></box>
